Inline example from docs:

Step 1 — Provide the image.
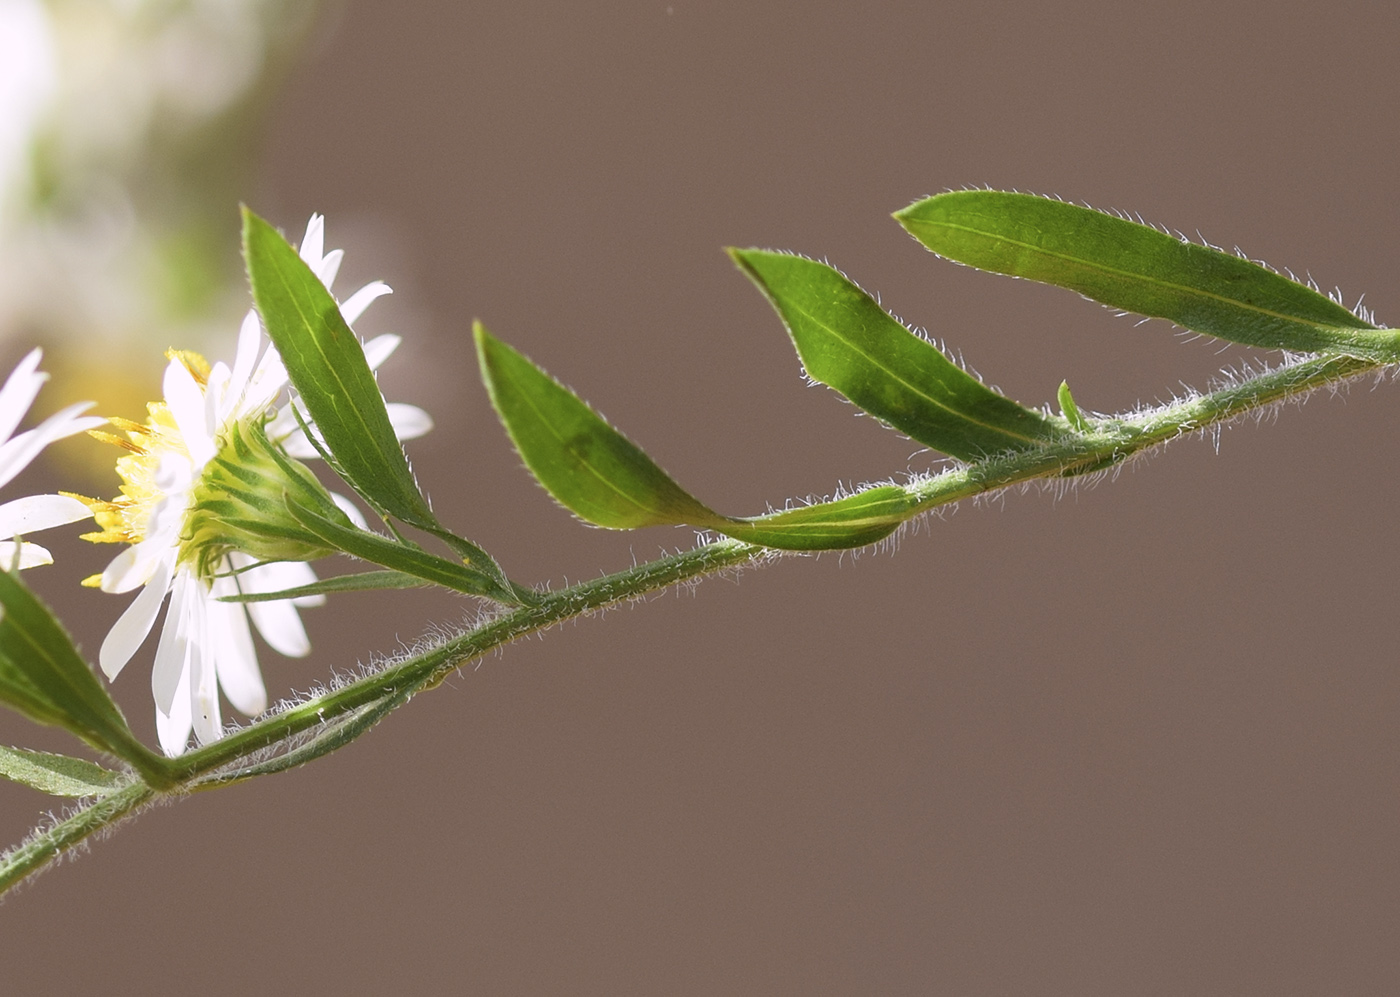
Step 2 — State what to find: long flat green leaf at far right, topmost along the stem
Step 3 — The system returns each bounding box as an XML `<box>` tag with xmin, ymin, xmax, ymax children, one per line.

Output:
<box><xmin>895</xmin><ymin>190</ymin><xmax>1394</xmax><ymax>356</ymax></box>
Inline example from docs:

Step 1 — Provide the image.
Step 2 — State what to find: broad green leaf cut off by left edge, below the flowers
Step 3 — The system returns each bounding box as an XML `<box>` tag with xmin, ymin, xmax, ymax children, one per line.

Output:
<box><xmin>0</xmin><ymin>571</ymin><xmax>150</xmax><ymax>766</ymax></box>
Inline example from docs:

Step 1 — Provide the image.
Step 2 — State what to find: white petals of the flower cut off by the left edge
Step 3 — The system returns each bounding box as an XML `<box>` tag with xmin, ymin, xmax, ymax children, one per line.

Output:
<box><xmin>0</xmin><ymin>349</ymin><xmax>106</xmax><ymax>569</ymax></box>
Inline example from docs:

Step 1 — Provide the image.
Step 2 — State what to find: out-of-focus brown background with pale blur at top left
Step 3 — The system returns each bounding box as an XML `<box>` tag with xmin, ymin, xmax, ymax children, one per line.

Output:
<box><xmin>0</xmin><ymin>0</ymin><xmax>1400</xmax><ymax>994</ymax></box>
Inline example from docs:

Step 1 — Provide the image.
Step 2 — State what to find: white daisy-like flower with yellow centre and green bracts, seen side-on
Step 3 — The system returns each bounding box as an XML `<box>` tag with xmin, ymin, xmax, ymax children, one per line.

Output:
<box><xmin>85</xmin><ymin>214</ymin><xmax>433</xmax><ymax>756</ymax></box>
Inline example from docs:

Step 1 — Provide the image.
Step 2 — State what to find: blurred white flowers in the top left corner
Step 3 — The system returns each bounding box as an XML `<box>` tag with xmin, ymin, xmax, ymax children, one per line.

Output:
<box><xmin>0</xmin><ymin>0</ymin><xmax>329</xmax><ymax>375</ymax></box>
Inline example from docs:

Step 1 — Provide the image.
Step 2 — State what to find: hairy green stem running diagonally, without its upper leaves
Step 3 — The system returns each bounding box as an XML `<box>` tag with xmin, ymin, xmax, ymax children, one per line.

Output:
<box><xmin>0</xmin><ymin>356</ymin><xmax>1385</xmax><ymax>892</ymax></box>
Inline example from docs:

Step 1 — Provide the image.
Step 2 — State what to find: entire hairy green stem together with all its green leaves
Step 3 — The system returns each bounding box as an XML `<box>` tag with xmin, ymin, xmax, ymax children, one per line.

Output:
<box><xmin>10</xmin><ymin>190</ymin><xmax>1400</xmax><ymax>889</ymax></box>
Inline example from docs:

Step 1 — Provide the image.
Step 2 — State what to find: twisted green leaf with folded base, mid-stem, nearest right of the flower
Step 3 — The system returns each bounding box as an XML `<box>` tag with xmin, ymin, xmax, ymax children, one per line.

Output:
<box><xmin>475</xmin><ymin>323</ymin><xmax>911</xmax><ymax>550</ymax></box>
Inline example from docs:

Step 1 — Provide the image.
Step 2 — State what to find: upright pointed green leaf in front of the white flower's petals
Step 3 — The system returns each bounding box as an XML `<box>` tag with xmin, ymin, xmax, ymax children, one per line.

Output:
<box><xmin>244</xmin><ymin>207</ymin><xmax>438</xmax><ymax>528</ymax></box>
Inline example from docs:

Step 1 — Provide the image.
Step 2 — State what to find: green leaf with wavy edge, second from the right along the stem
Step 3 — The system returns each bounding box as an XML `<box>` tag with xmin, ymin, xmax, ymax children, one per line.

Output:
<box><xmin>729</xmin><ymin>249</ymin><xmax>1061</xmax><ymax>461</ymax></box>
